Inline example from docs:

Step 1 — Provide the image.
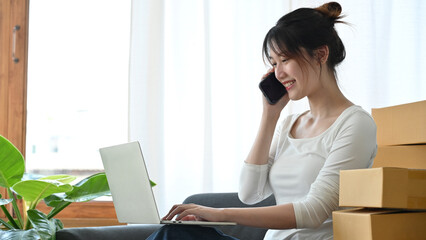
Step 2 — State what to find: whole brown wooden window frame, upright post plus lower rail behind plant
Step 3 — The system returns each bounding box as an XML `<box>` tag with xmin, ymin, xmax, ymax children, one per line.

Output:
<box><xmin>0</xmin><ymin>0</ymin><xmax>120</xmax><ymax>227</ymax></box>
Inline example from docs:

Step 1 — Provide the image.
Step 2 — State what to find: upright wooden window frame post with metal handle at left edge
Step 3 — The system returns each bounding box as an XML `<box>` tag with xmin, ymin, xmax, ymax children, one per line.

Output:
<box><xmin>0</xmin><ymin>0</ymin><xmax>29</xmax><ymax>220</ymax></box>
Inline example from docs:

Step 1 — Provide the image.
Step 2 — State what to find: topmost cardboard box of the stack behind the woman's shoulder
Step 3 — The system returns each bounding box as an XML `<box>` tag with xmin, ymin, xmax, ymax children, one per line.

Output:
<box><xmin>371</xmin><ymin>101</ymin><xmax>426</xmax><ymax>145</ymax></box>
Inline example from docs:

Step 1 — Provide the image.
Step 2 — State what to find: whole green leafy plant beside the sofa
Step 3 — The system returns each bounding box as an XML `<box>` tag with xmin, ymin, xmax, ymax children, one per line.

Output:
<box><xmin>0</xmin><ymin>136</ymin><xmax>110</xmax><ymax>240</ymax></box>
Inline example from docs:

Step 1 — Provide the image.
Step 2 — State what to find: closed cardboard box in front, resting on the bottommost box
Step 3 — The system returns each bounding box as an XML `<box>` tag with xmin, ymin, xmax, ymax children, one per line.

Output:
<box><xmin>339</xmin><ymin>167</ymin><xmax>426</xmax><ymax>209</ymax></box>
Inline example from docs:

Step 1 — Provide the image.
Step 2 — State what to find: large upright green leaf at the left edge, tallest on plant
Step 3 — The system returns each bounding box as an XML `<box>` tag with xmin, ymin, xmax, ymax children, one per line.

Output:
<box><xmin>0</xmin><ymin>135</ymin><xmax>25</xmax><ymax>188</ymax></box>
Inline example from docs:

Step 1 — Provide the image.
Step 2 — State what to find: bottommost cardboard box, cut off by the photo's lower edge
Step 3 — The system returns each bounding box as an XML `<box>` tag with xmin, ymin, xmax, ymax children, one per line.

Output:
<box><xmin>333</xmin><ymin>209</ymin><xmax>426</xmax><ymax>240</ymax></box>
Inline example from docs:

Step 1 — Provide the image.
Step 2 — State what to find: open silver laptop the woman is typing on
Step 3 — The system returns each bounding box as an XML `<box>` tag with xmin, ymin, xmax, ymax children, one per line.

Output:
<box><xmin>99</xmin><ymin>142</ymin><xmax>236</xmax><ymax>225</ymax></box>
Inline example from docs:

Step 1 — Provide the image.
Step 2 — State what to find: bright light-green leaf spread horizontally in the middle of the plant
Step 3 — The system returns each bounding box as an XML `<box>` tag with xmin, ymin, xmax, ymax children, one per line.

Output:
<box><xmin>12</xmin><ymin>180</ymin><xmax>72</xmax><ymax>202</ymax></box>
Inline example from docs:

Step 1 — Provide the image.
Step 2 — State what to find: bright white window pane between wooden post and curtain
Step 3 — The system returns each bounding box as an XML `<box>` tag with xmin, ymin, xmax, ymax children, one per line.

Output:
<box><xmin>26</xmin><ymin>0</ymin><xmax>131</xmax><ymax>182</ymax></box>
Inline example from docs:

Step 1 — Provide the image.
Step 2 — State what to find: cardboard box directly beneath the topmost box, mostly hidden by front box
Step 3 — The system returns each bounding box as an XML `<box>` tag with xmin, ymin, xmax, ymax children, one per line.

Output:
<box><xmin>373</xmin><ymin>145</ymin><xmax>426</xmax><ymax>169</ymax></box>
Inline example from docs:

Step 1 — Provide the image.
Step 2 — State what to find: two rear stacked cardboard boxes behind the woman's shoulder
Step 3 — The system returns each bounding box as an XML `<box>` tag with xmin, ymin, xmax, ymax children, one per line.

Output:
<box><xmin>372</xmin><ymin>101</ymin><xmax>426</xmax><ymax>169</ymax></box>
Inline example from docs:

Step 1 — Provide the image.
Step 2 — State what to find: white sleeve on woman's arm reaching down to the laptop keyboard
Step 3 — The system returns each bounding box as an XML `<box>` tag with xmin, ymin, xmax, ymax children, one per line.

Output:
<box><xmin>293</xmin><ymin>112</ymin><xmax>377</xmax><ymax>228</ymax></box>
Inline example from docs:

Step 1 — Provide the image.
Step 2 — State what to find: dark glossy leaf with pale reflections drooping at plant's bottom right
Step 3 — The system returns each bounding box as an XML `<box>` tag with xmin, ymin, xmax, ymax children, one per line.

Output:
<box><xmin>27</xmin><ymin>209</ymin><xmax>60</xmax><ymax>240</ymax></box>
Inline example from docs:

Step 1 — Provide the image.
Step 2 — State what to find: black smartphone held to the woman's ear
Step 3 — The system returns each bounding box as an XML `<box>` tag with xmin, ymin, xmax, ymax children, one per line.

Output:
<box><xmin>259</xmin><ymin>72</ymin><xmax>287</xmax><ymax>105</ymax></box>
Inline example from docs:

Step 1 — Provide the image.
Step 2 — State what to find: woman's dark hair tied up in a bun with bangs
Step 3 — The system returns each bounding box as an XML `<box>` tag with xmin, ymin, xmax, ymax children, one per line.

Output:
<box><xmin>262</xmin><ymin>2</ymin><xmax>346</xmax><ymax>73</ymax></box>
